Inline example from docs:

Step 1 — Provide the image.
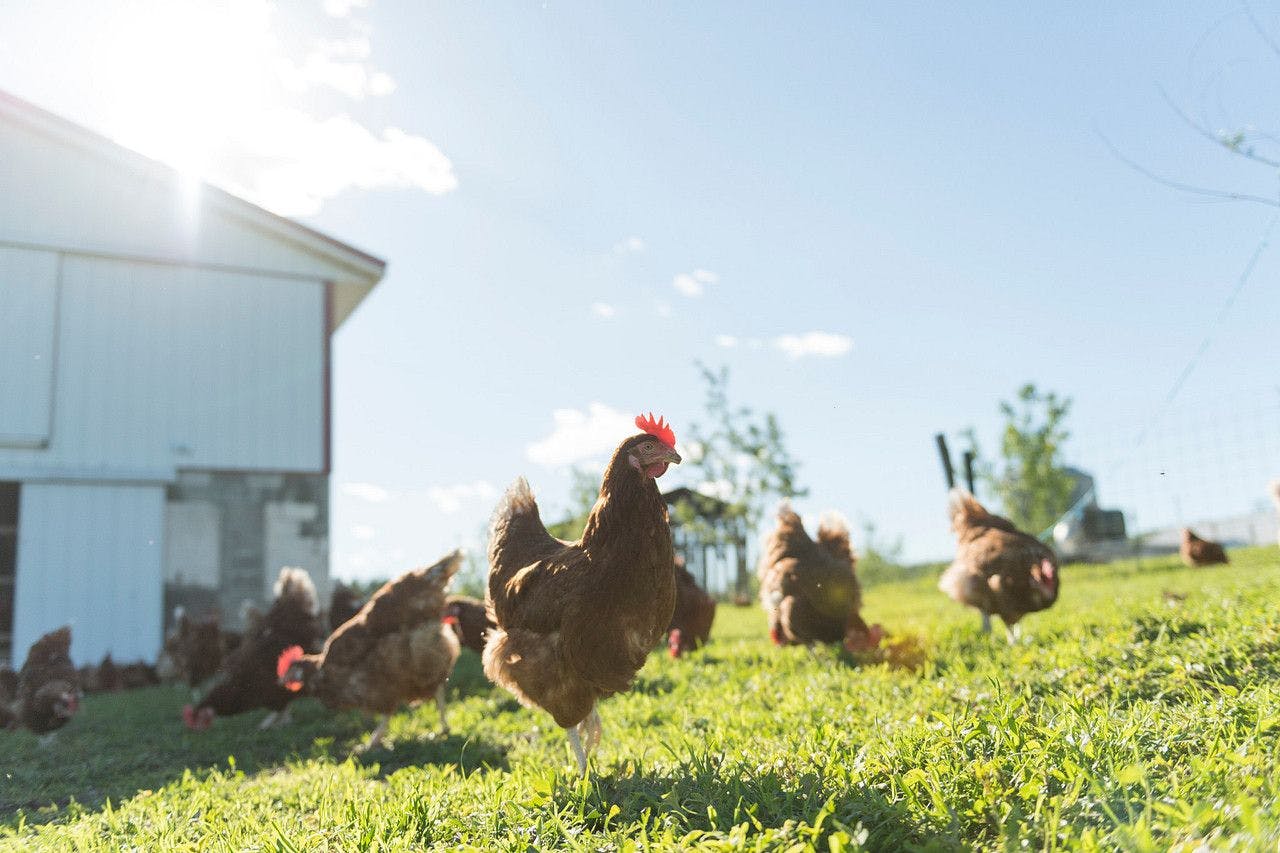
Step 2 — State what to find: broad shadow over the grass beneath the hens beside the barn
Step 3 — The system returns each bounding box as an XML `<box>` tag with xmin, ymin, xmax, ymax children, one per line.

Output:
<box><xmin>0</xmin><ymin>662</ymin><xmax>506</xmax><ymax>826</ymax></box>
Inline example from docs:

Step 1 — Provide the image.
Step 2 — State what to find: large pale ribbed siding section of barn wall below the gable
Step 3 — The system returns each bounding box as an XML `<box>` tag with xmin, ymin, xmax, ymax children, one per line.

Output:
<box><xmin>0</xmin><ymin>255</ymin><xmax>326</xmax><ymax>479</ymax></box>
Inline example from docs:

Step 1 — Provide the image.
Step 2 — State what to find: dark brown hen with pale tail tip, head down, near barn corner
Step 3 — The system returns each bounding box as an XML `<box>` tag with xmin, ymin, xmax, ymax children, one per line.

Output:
<box><xmin>182</xmin><ymin>567</ymin><xmax>324</xmax><ymax>731</ymax></box>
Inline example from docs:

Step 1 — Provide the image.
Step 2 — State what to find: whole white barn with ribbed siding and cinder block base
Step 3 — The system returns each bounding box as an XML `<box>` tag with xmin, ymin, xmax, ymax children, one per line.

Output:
<box><xmin>0</xmin><ymin>92</ymin><xmax>384</xmax><ymax>665</ymax></box>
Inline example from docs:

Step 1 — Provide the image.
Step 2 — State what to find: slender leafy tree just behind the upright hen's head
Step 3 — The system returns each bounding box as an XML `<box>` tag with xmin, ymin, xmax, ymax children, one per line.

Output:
<box><xmin>673</xmin><ymin>361</ymin><xmax>808</xmax><ymax>594</ymax></box>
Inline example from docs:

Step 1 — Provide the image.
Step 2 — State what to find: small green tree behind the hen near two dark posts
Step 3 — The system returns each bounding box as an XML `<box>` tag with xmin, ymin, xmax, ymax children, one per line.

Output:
<box><xmin>983</xmin><ymin>384</ymin><xmax>1074</xmax><ymax>534</ymax></box>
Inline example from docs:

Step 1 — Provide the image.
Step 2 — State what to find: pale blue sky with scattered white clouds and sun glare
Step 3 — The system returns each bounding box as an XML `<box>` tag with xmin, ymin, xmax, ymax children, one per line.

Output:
<box><xmin>0</xmin><ymin>0</ymin><xmax>1280</xmax><ymax>576</ymax></box>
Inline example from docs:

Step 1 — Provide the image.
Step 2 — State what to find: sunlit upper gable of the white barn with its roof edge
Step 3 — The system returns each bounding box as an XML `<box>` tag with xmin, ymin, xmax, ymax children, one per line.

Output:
<box><xmin>0</xmin><ymin>90</ymin><xmax>387</xmax><ymax>332</ymax></box>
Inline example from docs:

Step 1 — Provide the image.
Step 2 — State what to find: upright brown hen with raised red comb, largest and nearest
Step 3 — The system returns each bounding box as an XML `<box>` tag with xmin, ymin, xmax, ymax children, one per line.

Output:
<box><xmin>483</xmin><ymin>415</ymin><xmax>680</xmax><ymax>775</ymax></box>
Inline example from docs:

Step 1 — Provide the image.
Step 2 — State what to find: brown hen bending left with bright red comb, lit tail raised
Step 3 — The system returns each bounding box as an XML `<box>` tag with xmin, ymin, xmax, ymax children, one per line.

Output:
<box><xmin>276</xmin><ymin>551</ymin><xmax>462</xmax><ymax>749</ymax></box>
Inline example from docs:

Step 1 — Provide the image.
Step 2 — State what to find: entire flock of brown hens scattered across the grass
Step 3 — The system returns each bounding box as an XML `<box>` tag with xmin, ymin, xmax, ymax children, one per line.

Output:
<box><xmin>0</xmin><ymin>415</ymin><xmax>1259</xmax><ymax>774</ymax></box>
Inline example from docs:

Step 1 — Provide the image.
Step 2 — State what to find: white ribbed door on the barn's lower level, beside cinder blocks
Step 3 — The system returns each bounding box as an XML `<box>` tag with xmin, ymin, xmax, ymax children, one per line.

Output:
<box><xmin>14</xmin><ymin>483</ymin><xmax>164</xmax><ymax>665</ymax></box>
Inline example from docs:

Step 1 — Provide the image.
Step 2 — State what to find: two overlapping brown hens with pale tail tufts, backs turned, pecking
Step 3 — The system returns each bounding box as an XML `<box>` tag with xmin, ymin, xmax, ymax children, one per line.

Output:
<box><xmin>756</xmin><ymin>503</ymin><xmax>884</xmax><ymax>652</ymax></box>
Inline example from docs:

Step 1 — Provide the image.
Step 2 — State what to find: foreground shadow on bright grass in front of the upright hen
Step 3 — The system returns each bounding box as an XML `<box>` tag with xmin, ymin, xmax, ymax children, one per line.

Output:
<box><xmin>553</xmin><ymin>758</ymin><xmax>966</xmax><ymax>850</ymax></box>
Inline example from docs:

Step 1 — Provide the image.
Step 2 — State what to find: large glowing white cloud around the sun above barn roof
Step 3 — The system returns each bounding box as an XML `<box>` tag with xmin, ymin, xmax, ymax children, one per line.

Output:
<box><xmin>68</xmin><ymin>0</ymin><xmax>458</xmax><ymax>216</ymax></box>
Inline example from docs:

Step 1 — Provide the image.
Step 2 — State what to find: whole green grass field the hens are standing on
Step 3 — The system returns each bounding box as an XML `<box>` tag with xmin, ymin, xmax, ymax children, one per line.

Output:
<box><xmin>0</xmin><ymin>548</ymin><xmax>1280</xmax><ymax>850</ymax></box>
